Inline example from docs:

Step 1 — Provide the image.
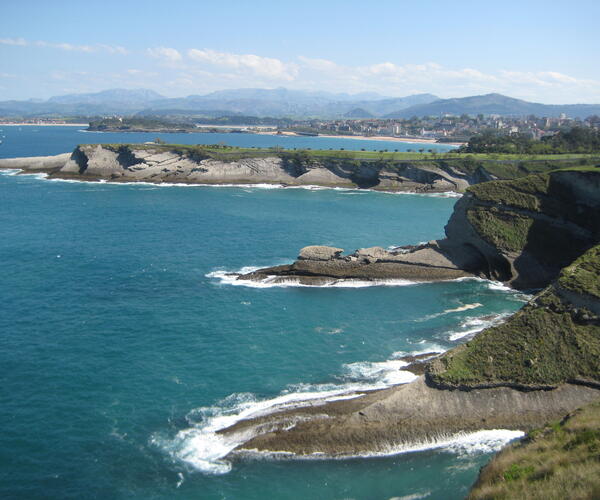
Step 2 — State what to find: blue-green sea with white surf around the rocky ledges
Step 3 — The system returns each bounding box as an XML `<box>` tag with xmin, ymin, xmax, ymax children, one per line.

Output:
<box><xmin>0</xmin><ymin>126</ymin><xmax>527</xmax><ymax>500</ymax></box>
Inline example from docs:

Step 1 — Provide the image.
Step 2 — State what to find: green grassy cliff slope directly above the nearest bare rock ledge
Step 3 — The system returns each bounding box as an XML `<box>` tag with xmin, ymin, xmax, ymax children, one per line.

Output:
<box><xmin>428</xmin><ymin>245</ymin><xmax>600</xmax><ymax>388</ymax></box>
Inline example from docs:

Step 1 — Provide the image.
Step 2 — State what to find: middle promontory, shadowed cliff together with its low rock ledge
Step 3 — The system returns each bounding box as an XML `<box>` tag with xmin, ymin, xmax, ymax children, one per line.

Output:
<box><xmin>241</xmin><ymin>168</ymin><xmax>600</xmax><ymax>289</ymax></box>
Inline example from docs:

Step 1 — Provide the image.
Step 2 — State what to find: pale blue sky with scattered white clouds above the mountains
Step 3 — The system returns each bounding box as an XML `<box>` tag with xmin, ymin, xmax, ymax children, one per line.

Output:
<box><xmin>0</xmin><ymin>0</ymin><xmax>600</xmax><ymax>104</ymax></box>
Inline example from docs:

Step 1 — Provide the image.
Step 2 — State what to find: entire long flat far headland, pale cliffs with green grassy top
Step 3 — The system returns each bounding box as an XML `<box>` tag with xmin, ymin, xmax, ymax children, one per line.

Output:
<box><xmin>0</xmin><ymin>143</ymin><xmax>600</xmax><ymax>193</ymax></box>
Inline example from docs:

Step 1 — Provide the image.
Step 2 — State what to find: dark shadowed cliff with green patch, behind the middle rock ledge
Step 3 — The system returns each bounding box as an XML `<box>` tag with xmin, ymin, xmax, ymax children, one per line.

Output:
<box><xmin>440</xmin><ymin>169</ymin><xmax>600</xmax><ymax>289</ymax></box>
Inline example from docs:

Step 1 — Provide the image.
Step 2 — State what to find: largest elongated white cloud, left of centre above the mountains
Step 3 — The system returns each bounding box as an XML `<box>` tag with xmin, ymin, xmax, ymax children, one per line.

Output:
<box><xmin>188</xmin><ymin>49</ymin><xmax>298</xmax><ymax>81</ymax></box>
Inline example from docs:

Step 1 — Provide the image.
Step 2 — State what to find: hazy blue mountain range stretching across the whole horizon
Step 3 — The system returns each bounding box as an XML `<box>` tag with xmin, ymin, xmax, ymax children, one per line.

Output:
<box><xmin>0</xmin><ymin>88</ymin><xmax>600</xmax><ymax>119</ymax></box>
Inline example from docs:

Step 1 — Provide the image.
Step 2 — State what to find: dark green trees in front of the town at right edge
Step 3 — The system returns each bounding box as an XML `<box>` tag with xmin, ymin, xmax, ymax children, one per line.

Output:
<box><xmin>458</xmin><ymin>127</ymin><xmax>600</xmax><ymax>154</ymax></box>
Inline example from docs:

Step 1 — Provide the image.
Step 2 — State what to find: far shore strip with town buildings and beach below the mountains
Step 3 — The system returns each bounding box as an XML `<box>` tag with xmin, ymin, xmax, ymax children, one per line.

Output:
<box><xmin>5</xmin><ymin>113</ymin><xmax>600</xmax><ymax>143</ymax></box>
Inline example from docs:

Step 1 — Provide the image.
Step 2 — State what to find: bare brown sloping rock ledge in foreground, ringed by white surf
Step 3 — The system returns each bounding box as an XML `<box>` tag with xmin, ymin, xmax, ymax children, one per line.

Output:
<box><xmin>220</xmin><ymin>377</ymin><xmax>600</xmax><ymax>457</ymax></box>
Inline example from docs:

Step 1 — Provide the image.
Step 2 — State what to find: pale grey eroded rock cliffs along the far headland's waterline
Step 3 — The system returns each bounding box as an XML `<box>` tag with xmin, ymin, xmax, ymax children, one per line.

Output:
<box><xmin>0</xmin><ymin>144</ymin><xmax>474</xmax><ymax>192</ymax></box>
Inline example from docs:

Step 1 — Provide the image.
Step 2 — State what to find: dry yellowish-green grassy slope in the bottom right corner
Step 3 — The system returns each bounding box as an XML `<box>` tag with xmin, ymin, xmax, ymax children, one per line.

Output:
<box><xmin>468</xmin><ymin>403</ymin><xmax>600</xmax><ymax>500</ymax></box>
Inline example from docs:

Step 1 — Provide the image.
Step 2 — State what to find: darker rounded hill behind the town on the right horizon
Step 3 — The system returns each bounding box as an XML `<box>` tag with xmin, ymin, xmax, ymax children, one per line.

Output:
<box><xmin>385</xmin><ymin>94</ymin><xmax>600</xmax><ymax>118</ymax></box>
